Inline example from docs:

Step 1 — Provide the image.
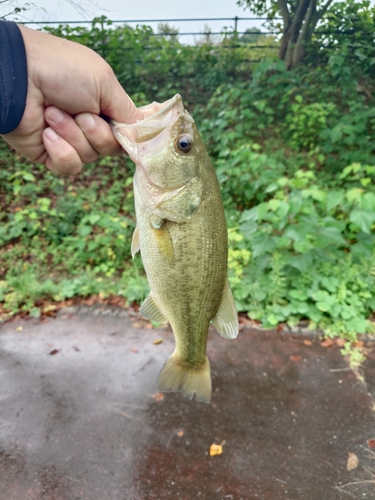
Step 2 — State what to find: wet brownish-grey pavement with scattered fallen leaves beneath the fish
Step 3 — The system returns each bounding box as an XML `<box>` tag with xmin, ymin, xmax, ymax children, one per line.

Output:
<box><xmin>0</xmin><ymin>307</ymin><xmax>375</xmax><ymax>500</ymax></box>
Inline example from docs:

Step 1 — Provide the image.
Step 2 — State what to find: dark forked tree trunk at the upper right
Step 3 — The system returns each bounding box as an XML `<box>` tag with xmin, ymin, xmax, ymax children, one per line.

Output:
<box><xmin>237</xmin><ymin>0</ymin><xmax>333</xmax><ymax>68</ymax></box>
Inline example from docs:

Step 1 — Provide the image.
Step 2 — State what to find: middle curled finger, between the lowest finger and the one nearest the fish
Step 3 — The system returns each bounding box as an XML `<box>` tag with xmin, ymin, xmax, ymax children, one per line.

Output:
<box><xmin>45</xmin><ymin>106</ymin><xmax>98</xmax><ymax>163</ymax></box>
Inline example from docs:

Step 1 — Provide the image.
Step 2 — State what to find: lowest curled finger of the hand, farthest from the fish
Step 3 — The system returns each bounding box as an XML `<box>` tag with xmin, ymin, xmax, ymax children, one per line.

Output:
<box><xmin>43</xmin><ymin>128</ymin><xmax>82</xmax><ymax>175</ymax></box>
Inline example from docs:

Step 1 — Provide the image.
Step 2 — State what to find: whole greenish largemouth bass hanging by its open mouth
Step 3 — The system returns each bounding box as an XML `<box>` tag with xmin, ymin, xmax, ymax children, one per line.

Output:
<box><xmin>111</xmin><ymin>94</ymin><xmax>238</xmax><ymax>403</ymax></box>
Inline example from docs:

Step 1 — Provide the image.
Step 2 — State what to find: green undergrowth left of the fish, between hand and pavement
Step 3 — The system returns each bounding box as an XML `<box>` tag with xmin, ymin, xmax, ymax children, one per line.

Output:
<box><xmin>0</xmin><ymin>138</ymin><xmax>145</xmax><ymax>312</ymax></box>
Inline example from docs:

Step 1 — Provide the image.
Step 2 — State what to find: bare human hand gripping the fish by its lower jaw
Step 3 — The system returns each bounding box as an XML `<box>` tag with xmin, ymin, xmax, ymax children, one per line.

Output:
<box><xmin>3</xmin><ymin>26</ymin><xmax>142</xmax><ymax>175</ymax></box>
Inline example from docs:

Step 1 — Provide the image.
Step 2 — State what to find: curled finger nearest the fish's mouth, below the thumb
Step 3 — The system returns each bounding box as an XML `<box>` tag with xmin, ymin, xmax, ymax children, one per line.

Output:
<box><xmin>75</xmin><ymin>113</ymin><xmax>122</xmax><ymax>156</ymax></box>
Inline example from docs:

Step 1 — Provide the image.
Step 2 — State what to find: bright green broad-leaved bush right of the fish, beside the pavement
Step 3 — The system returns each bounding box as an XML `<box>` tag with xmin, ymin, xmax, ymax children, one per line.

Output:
<box><xmin>233</xmin><ymin>171</ymin><xmax>375</xmax><ymax>340</ymax></box>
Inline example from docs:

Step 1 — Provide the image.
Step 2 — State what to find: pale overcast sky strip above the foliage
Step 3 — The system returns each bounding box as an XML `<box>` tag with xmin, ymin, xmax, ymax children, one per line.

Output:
<box><xmin>0</xmin><ymin>0</ymin><xmax>268</xmax><ymax>42</ymax></box>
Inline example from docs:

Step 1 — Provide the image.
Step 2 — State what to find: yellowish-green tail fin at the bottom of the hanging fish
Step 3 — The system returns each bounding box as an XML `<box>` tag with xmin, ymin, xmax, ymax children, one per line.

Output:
<box><xmin>158</xmin><ymin>354</ymin><xmax>211</xmax><ymax>403</ymax></box>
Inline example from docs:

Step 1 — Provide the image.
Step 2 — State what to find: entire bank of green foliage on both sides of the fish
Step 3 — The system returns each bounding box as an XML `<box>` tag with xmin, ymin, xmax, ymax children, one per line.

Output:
<box><xmin>0</xmin><ymin>17</ymin><xmax>375</xmax><ymax>344</ymax></box>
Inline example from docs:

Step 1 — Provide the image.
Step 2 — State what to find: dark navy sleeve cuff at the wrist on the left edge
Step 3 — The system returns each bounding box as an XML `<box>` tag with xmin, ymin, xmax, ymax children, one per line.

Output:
<box><xmin>0</xmin><ymin>21</ymin><xmax>27</xmax><ymax>134</ymax></box>
